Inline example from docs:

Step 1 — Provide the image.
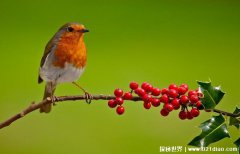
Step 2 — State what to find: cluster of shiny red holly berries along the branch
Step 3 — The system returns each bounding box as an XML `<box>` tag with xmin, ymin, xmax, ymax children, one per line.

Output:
<box><xmin>108</xmin><ymin>82</ymin><xmax>203</xmax><ymax>120</ymax></box>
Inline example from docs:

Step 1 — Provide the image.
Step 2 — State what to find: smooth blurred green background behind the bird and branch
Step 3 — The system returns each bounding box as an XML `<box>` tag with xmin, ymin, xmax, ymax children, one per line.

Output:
<box><xmin>0</xmin><ymin>0</ymin><xmax>240</xmax><ymax>154</ymax></box>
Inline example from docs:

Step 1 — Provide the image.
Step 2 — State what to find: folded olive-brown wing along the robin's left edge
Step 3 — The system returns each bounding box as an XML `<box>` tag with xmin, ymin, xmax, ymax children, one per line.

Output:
<box><xmin>38</xmin><ymin>37</ymin><xmax>55</xmax><ymax>83</ymax></box>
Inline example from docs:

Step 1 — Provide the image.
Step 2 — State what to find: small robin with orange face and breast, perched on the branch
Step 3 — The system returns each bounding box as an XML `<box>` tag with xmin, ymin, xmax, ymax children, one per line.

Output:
<box><xmin>38</xmin><ymin>23</ymin><xmax>88</xmax><ymax>113</ymax></box>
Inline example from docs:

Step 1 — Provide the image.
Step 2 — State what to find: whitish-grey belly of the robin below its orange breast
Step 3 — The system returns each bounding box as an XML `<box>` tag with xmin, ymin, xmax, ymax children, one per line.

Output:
<box><xmin>40</xmin><ymin>51</ymin><xmax>84</xmax><ymax>83</ymax></box>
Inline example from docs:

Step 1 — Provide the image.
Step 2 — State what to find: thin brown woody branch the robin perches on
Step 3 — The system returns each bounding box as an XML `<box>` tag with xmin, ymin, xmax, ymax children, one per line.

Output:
<box><xmin>0</xmin><ymin>95</ymin><xmax>240</xmax><ymax>129</ymax></box>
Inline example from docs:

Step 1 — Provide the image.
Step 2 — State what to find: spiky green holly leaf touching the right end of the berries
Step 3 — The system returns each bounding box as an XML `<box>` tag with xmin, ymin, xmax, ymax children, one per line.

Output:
<box><xmin>197</xmin><ymin>81</ymin><xmax>225</xmax><ymax>109</ymax></box>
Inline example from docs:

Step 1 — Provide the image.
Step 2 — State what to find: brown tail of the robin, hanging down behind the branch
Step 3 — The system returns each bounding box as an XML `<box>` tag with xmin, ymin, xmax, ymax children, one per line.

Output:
<box><xmin>40</xmin><ymin>82</ymin><xmax>56</xmax><ymax>113</ymax></box>
